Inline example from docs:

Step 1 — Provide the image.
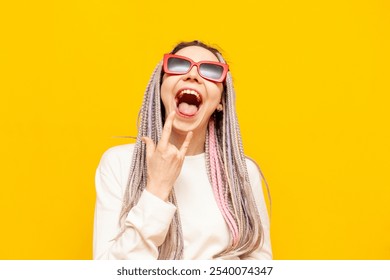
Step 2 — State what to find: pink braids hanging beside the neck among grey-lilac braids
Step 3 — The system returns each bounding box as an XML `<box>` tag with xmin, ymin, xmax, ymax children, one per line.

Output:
<box><xmin>209</xmin><ymin>120</ymin><xmax>238</xmax><ymax>245</ymax></box>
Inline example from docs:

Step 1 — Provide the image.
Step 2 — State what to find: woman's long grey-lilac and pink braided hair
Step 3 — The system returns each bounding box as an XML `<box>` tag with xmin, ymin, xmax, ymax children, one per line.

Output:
<box><xmin>119</xmin><ymin>41</ymin><xmax>263</xmax><ymax>259</ymax></box>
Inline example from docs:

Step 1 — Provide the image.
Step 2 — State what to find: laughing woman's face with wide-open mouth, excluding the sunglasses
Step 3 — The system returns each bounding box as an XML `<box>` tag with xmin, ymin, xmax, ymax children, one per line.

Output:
<box><xmin>161</xmin><ymin>46</ymin><xmax>223</xmax><ymax>136</ymax></box>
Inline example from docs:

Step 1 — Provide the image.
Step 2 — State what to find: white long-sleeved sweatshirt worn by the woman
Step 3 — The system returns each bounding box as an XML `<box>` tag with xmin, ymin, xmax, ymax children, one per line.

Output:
<box><xmin>93</xmin><ymin>144</ymin><xmax>272</xmax><ymax>260</ymax></box>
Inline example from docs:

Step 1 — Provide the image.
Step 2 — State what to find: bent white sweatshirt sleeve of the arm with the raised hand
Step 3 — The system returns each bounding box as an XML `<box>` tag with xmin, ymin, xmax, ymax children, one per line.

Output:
<box><xmin>93</xmin><ymin>146</ymin><xmax>176</xmax><ymax>260</ymax></box>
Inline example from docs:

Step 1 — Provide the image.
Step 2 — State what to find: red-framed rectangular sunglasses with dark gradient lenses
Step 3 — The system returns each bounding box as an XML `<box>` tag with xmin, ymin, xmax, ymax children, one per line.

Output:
<box><xmin>163</xmin><ymin>54</ymin><xmax>229</xmax><ymax>83</ymax></box>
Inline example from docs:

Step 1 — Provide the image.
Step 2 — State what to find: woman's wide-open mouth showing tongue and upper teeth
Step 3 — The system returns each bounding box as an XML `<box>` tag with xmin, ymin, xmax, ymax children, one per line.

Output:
<box><xmin>175</xmin><ymin>89</ymin><xmax>202</xmax><ymax>116</ymax></box>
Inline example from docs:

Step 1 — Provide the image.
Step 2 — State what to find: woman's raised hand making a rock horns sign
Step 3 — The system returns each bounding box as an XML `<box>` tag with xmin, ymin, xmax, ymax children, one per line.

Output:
<box><xmin>142</xmin><ymin>111</ymin><xmax>193</xmax><ymax>201</ymax></box>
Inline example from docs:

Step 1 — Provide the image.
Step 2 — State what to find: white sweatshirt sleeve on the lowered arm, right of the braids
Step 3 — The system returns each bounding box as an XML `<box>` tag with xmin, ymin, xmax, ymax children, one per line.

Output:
<box><xmin>245</xmin><ymin>159</ymin><xmax>272</xmax><ymax>260</ymax></box>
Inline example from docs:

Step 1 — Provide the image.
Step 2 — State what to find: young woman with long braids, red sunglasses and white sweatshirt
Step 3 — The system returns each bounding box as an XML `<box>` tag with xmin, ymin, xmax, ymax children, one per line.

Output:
<box><xmin>94</xmin><ymin>41</ymin><xmax>272</xmax><ymax>259</ymax></box>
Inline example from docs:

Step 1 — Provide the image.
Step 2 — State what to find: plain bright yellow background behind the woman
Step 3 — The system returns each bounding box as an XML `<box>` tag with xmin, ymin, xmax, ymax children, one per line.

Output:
<box><xmin>0</xmin><ymin>0</ymin><xmax>390</xmax><ymax>259</ymax></box>
